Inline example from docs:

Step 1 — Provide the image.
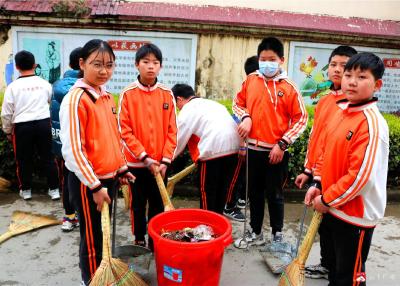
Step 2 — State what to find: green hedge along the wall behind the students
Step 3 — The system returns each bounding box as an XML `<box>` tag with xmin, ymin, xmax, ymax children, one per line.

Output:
<box><xmin>0</xmin><ymin>93</ymin><xmax>400</xmax><ymax>187</ymax></box>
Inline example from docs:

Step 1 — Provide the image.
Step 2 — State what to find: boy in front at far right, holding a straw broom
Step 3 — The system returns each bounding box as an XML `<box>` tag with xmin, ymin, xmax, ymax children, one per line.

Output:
<box><xmin>305</xmin><ymin>53</ymin><xmax>389</xmax><ymax>285</ymax></box>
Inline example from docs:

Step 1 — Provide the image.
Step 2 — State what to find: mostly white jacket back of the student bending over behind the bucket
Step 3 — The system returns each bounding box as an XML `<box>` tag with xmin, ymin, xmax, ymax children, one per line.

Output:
<box><xmin>176</xmin><ymin>97</ymin><xmax>240</xmax><ymax>162</ymax></box>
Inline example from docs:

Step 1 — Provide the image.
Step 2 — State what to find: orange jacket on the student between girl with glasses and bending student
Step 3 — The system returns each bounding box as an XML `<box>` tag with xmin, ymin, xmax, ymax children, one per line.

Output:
<box><xmin>118</xmin><ymin>80</ymin><xmax>177</xmax><ymax>168</ymax></box>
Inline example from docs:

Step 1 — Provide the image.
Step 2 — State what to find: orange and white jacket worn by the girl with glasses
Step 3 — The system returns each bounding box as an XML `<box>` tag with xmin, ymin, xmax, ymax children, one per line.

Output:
<box><xmin>60</xmin><ymin>79</ymin><xmax>128</xmax><ymax>192</ymax></box>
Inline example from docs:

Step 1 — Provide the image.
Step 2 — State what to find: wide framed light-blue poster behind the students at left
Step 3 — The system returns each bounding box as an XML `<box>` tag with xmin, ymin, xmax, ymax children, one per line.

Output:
<box><xmin>12</xmin><ymin>27</ymin><xmax>197</xmax><ymax>94</ymax></box>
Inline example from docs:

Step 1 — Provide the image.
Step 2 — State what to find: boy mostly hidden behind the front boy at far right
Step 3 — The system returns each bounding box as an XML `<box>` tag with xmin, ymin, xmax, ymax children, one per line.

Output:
<box><xmin>295</xmin><ymin>46</ymin><xmax>357</xmax><ymax>279</ymax></box>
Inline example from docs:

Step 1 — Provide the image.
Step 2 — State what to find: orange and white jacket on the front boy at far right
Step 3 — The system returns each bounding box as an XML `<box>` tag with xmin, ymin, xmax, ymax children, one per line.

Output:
<box><xmin>314</xmin><ymin>98</ymin><xmax>389</xmax><ymax>227</ymax></box>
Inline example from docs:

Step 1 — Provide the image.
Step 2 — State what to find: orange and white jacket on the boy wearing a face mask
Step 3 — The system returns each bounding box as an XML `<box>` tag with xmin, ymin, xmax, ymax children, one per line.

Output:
<box><xmin>232</xmin><ymin>71</ymin><xmax>308</xmax><ymax>148</ymax></box>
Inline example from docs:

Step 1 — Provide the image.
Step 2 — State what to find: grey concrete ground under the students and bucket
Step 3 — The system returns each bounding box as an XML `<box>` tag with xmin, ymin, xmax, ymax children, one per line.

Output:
<box><xmin>0</xmin><ymin>192</ymin><xmax>400</xmax><ymax>286</ymax></box>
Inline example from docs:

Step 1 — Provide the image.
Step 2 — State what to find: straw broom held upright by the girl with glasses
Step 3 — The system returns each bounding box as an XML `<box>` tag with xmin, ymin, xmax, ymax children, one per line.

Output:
<box><xmin>89</xmin><ymin>202</ymin><xmax>147</xmax><ymax>286</ymax></box>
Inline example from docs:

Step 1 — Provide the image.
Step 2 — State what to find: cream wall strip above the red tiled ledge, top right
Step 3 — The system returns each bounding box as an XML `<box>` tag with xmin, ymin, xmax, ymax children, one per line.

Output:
<box><xmin>128</xmin><ymin>0</ymin><xmax>400</xmax><ymax>21</ymax></box>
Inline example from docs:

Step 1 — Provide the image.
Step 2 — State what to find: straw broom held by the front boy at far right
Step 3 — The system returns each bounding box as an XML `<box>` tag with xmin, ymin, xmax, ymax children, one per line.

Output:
<box><xmin>278</xmin><ymin>211</ymin><xmax>322</xmax><ymax>286</ymax></box>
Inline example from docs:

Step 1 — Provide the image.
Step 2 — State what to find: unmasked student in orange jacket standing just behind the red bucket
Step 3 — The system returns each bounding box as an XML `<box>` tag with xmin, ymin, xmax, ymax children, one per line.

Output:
<box><xmin>118</xmin><ymin>44</ymin><xmax>177</xmax><ymax>248</ymax></box>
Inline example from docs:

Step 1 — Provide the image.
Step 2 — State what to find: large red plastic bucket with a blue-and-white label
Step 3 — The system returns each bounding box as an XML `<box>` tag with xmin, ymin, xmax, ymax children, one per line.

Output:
<box><xmin>148</xmin><ymin>209</ymin><xmax>232</xmax><ymax>286</ymax></box>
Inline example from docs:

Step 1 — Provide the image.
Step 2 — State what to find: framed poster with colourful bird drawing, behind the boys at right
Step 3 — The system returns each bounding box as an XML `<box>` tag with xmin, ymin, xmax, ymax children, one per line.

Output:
<box><xmin>288</xmin><ymin>42</ymin><xmax>400</xmax><ymax>112</ymax></box>
